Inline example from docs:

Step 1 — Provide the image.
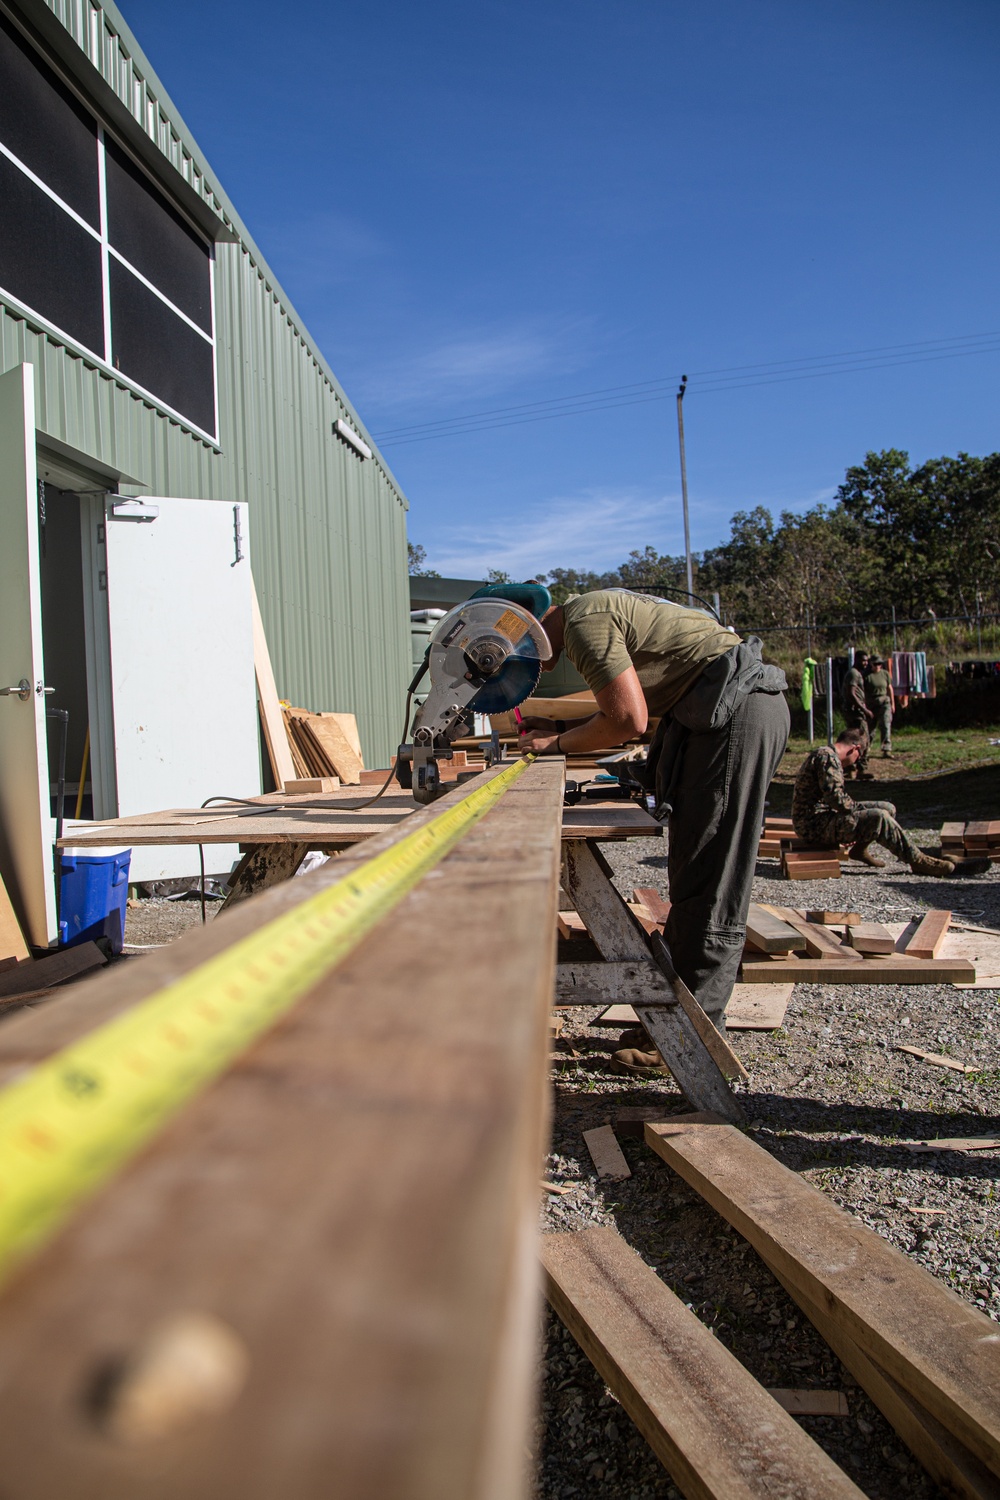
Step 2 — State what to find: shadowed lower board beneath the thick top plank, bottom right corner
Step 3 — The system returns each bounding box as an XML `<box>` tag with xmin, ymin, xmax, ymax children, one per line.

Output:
<box><xmin>765</xmin><ymin>1262</ymin><xmax>1000</xmax><ymax>1500</ymax></box>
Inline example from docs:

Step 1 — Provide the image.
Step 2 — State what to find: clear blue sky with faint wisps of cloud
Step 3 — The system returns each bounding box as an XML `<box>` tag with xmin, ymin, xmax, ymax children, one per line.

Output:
<box><xmin>123</xmin><ymin>0</ymin><xmax>1000</xmax><ymax>578</ymax></box>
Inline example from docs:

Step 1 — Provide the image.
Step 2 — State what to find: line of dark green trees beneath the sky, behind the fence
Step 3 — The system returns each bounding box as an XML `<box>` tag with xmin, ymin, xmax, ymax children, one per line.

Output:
<box><xmin>411</xmin><ymin>449</ymin><xmax>1000</xmax><ymax>630</ymax></box>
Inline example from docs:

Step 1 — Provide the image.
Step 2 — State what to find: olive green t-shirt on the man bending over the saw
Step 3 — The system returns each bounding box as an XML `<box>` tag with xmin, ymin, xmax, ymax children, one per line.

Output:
<box><xmin>562</xmin><ymin>588</ymin><xmax>741</xmax><ymax>716</ymax></box>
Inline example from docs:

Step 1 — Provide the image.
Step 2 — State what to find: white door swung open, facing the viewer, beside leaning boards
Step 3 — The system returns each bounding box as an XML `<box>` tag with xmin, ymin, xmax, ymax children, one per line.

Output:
<box><xmin>98</xmin><ymin>497</ymin><xmax>261</xmax><ymax>881</ymax></box>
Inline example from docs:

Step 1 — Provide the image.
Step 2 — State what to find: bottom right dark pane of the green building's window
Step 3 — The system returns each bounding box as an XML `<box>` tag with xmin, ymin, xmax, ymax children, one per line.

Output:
<box><xmin>108</xmin><ymin>257</ymin><xmax>216</xmax><ymax>434</ymax></box>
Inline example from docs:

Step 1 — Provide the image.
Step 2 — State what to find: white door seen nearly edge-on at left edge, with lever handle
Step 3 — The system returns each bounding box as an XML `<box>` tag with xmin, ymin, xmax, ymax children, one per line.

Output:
<box><xmin>0</xmin><ymin>365</ymin><xmax>55</xmax><ymax>947</ymax></box>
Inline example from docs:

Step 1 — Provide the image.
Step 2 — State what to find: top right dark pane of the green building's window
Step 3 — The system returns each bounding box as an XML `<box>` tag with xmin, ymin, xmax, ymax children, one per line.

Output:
<box><xmin>105</xmin><ymin>140</ymin><xmax>211</xmax><ymax>333</ymax></box>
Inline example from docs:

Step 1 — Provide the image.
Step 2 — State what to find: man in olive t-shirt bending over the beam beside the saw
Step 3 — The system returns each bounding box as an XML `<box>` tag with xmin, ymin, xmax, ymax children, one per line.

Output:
<box><xmin>509</xmin><ymin>585</ymin><xmax>789</xmax><ymax>1038</ymax></box>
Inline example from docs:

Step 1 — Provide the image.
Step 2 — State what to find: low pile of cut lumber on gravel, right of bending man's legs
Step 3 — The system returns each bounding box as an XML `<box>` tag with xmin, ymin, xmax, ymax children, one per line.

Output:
<box><xmin>741</xmin><ymin>905</ymin><xmax>976</xmax><ymax>984</ymax></box>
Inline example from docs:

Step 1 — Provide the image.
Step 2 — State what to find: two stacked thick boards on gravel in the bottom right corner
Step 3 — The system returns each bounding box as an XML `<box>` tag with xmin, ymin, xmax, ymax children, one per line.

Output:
<box><xmin>644</xmin><ymin>1118</ymin><xmax>1000</xmax><ymax>1497</ymax></box>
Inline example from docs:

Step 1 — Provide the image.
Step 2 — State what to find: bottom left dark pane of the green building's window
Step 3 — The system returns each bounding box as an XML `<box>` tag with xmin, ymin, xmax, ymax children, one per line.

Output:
<box><xmin>0</xmin><ymin>156</ymin><xmax>103</xmax><ymax>359</ymax></box>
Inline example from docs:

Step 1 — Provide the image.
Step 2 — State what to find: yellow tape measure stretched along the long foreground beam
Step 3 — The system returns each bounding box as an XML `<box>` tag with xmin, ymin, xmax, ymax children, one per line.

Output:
<box><xmin>0</xmin><ymin>758</ymin><xmax>534</xmax><ymax>1278</ymax></box>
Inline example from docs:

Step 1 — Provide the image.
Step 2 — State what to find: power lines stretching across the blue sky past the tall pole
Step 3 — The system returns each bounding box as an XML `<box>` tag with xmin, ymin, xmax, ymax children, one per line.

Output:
<box><xmin>376</xmin><ymin>332</ymin><xmax>1000</xmax><ymax>447</ymax></box>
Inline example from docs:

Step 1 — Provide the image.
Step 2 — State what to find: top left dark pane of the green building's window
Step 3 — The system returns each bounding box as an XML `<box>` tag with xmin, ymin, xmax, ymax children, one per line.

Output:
<box><xmin>0</xmin><ymin>15</ymin><xmax>100</xmax><ymax>230</ymax></box>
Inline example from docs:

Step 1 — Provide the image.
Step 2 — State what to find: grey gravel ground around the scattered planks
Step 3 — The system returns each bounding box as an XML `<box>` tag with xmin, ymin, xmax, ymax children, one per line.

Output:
<box><xmin>537</xmin><ymin>834</ymin><xmax>1000</xmax><ymax>1500</ymax></box>
